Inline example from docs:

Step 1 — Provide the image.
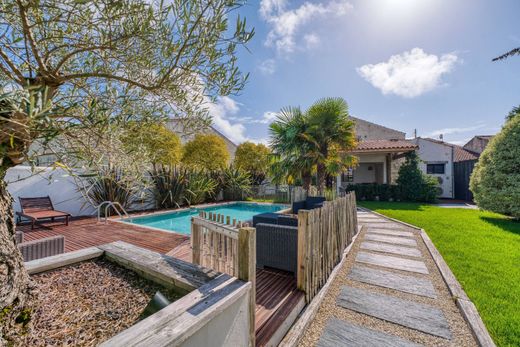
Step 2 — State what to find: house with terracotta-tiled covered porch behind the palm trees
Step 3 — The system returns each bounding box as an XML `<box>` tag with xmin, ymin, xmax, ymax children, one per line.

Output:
<box><xmin>337</xmin><ymin>117</ymin><xmax>417</xmax><ymax>189</ymax></box>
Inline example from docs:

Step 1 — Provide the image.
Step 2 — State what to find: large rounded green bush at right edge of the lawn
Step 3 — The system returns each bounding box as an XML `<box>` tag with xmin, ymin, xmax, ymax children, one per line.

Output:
<box><xmin>470</xmin><ymin>116</ymin><xmax>520</xmax><ymax>218</ymax></box>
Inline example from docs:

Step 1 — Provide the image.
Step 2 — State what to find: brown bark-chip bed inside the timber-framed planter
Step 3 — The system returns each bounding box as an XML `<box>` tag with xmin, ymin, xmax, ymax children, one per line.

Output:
<box><xmin>26</xmin><ymin>259</ymin><xmax>180</xmax><ymax>346</ymax></box>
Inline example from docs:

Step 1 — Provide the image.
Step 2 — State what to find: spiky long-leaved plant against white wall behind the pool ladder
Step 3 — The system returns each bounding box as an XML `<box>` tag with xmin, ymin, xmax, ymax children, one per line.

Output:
<box><xmin>83</xmin><ymin>167</ymin><xmax>138</xmax><ymax>213</ymax></box>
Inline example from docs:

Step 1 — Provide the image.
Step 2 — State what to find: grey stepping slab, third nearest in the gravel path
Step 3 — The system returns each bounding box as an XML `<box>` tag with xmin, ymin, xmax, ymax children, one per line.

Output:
<box><xmin>347</xmin><ymin>265</ymin><xmax>437</xmax><ymax>299</ymax></box>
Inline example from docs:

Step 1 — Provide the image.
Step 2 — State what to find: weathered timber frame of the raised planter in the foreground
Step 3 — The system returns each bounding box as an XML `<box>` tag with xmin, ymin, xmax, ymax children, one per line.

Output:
<box><xmin>25</xmin><ymin>241</ymin><xmax>252</xmax><ymax>346</ymax></box>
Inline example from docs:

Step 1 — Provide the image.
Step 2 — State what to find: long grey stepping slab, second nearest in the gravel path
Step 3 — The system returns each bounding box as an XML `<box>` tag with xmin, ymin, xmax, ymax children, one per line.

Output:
<box><xmin>336</xmin><ymin>286</ymin><xmax>451</xmax><ymax>340</ymax></box>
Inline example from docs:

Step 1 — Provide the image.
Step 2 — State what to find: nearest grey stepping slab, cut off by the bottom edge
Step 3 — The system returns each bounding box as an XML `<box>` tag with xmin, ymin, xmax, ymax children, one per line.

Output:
<box><xmin>317</xmin><ymin>318</ymin><xmax>421</xmax><ymax>347</ymax></box>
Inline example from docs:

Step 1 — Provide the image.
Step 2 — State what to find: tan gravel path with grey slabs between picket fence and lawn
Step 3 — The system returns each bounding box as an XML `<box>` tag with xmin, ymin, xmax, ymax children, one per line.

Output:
<box><xmin>300</xmin><ymin>212</ymin><xmax>476</xmax><ymax>347</ymax></box>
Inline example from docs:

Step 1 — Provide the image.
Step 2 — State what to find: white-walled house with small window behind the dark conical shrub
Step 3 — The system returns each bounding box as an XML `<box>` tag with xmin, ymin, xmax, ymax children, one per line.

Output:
<box><xmin>409</xmin><ymin>137</ymin><xmax>455</xmax><ymax>199</ymax></box>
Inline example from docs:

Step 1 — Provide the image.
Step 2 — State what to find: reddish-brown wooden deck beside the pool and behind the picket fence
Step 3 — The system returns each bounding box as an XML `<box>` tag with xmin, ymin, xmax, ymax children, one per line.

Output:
<box><xmin>17</xmin><ymin>218</ymin><xmax>303</xmax><ymax>346</ymax></box>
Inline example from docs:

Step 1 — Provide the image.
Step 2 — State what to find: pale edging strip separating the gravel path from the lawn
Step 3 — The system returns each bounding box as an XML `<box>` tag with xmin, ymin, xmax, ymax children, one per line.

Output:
<box><xmin>358</xmin><ymin>206</ymin><xmax>496</xmax><ymax>347</ymax></box>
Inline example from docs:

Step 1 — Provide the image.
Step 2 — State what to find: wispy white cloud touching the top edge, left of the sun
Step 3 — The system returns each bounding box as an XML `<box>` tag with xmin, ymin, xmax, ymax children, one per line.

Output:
<box><xmin>259</xmin><ymin>0</ymin><xmax>353</xmax><ymax>54</ymax></box>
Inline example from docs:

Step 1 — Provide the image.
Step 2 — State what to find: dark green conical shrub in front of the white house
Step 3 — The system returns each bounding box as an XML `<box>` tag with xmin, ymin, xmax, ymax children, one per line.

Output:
<box><xmin>396</xmin><ymin>152</ymin><xmax>437</xmax><ymax>202</ymax></box>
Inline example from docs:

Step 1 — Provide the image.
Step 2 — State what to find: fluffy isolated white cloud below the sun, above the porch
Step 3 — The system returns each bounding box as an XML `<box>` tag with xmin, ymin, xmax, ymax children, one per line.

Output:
<box><xmin>357</xmin><ymin>48</ymin><xmax>459</xmax><ymax>98</ymax></box>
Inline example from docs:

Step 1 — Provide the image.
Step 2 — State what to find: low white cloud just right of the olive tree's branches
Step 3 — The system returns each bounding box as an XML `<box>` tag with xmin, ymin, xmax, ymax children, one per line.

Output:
<box><xmin>206</xmin><ymin>96</ymin><xmax>248</xmax><ymax>143</ymax></box>
